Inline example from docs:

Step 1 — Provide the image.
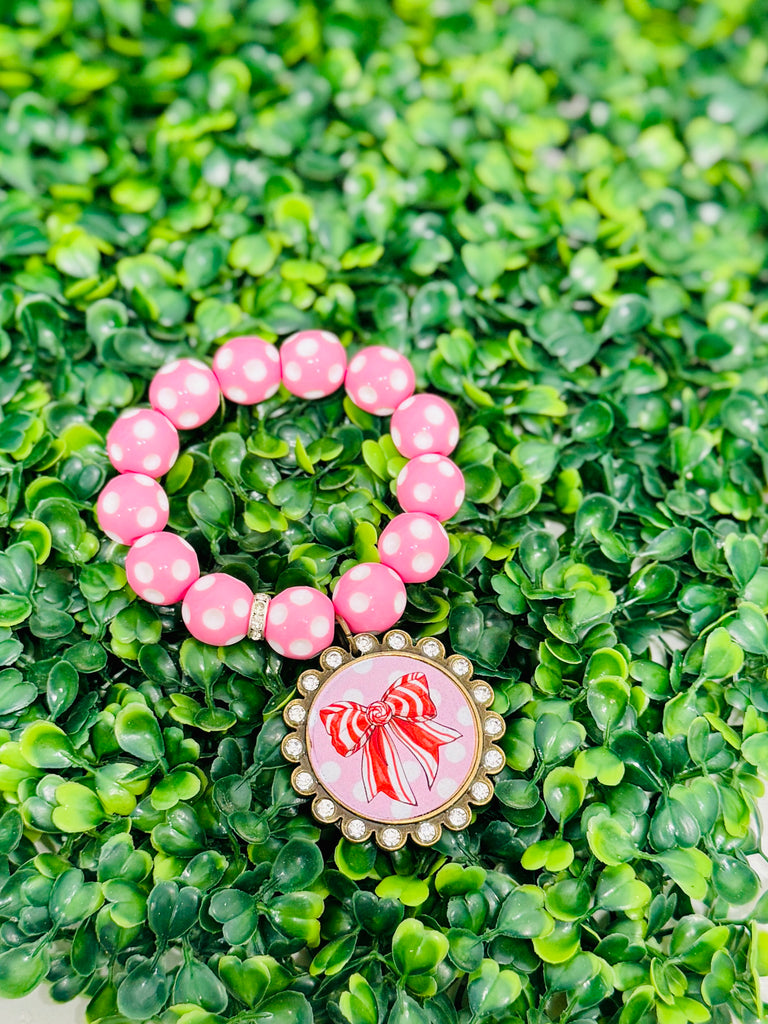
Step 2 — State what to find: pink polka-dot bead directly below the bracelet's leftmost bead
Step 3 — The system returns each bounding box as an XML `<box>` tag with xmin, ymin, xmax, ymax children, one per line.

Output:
<box><xmin>125</xmin><ymin>531</ymin><xmax>200</xmax><ymax>604</ymax></box>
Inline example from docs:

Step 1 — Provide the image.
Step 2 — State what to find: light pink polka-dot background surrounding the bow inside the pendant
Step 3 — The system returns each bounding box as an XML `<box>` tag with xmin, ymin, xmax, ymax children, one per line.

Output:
<box><xmin>306</xmin><ymin>653</ymin><xmax>481</xmax><ymax>822</ymax></box>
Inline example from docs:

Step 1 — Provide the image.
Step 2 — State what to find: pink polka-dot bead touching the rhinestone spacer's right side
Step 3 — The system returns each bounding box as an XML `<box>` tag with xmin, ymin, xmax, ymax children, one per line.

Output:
<box><xmin>264</xmin><ymin>587</ymin><xmax>336</xmax><ymax>658</ymax></box>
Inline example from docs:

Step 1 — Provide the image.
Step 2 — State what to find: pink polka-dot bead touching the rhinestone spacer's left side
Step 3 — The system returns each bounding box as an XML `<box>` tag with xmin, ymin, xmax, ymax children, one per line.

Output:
<box><xmin>181</xmin><ymin>572</ymin><xmax>253</xmax><ymax>647</ymax></box>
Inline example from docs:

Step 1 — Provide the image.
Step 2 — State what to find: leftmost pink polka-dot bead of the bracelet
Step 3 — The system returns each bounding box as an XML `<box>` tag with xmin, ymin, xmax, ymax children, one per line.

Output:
<box><xmin>96</xmin><ymin>473</ymin><xmax>168</xmax><ymax>544</ymax></box>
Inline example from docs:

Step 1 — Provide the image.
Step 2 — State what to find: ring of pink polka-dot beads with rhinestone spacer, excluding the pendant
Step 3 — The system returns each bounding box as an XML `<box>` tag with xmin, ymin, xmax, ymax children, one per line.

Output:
<box><xmin>97</xmin><ymin>331</ymin><xmax>464</xmax><ymax>659</ymax></box>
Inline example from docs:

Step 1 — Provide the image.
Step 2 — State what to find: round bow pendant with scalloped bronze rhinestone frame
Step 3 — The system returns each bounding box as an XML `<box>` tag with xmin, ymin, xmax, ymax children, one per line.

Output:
<box><xmin>283</xmin><ymin>630</ymin><xmax>505</xmax><ymax>850</ymax></box>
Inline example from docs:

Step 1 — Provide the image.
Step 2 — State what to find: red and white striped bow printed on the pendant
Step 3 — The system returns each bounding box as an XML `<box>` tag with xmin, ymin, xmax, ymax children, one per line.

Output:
<box><xmin>319</xmin><ymin>672</ymin><xmax>461</xmax><ymax>804</ymax></box>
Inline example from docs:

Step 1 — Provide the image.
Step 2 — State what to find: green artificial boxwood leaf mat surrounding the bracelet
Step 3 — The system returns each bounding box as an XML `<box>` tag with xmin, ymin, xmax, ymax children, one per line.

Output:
<box><xmin>0</xmin><ymin>0</ymin><xmax>768</xmax><ymax>1024</ymax></box>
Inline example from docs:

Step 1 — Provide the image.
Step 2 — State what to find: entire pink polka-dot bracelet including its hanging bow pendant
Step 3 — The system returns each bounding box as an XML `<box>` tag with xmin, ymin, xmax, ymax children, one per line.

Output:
<box><xmin>97</xmin><ymin>331</ymin><xmax>505</xmax><ymax>850</ymax></box>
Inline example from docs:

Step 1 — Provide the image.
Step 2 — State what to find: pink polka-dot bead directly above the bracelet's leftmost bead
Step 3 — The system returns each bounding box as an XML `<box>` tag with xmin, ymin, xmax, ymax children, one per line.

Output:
<box><xmin>106</xmin><ymin>409</ymin><xmax>178</xmax><ymax>477</ymax></box>
